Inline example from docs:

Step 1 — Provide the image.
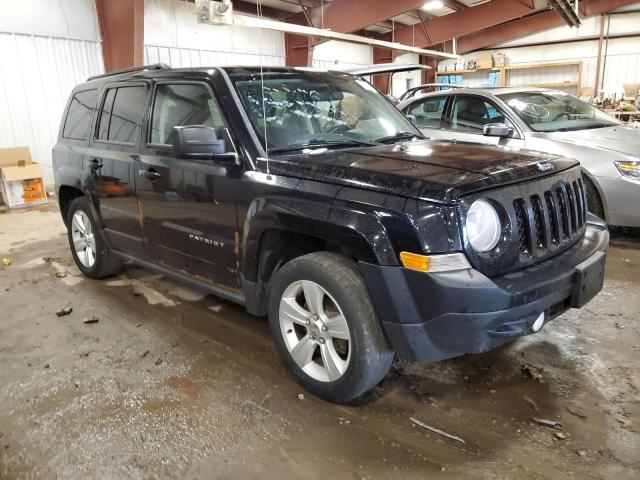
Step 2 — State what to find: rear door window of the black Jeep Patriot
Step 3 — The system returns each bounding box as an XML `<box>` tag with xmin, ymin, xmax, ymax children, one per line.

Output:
<box><xmin>97</xmin><ymin>85</ymin><xmax>145</xmax><ymax>143</ymax></box>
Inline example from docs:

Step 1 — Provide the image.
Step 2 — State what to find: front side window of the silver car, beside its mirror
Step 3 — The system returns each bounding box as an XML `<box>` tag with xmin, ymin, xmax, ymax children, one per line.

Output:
<box><xmin>449</xmin><ymin>96</ymin><xmax>513</xmax><ymax>134</ymax></box>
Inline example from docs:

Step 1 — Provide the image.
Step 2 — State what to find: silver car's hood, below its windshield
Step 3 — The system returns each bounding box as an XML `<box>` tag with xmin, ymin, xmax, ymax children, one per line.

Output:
<box><xmin>543</xmin><ymin>125</ymin><xmax>640</xmax><ymax>157</ymax></box>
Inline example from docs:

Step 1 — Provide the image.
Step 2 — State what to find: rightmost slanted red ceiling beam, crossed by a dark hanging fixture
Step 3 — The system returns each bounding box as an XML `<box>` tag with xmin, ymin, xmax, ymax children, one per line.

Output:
<box><xmin>457</xmin><ymin>0</ymin><xmax>638</xmax><ymax>53</ymax></box>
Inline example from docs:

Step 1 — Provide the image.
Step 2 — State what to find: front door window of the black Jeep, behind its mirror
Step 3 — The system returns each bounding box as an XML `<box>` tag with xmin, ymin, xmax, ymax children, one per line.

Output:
<box><xmin>149</xmin><ymin>84</ymin><xmax>225</xmax><ymax>145</ymax></box>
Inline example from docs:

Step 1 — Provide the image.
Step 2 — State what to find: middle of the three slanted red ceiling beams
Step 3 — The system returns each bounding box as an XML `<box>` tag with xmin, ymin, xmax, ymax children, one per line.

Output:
<box><xmin>385</xmin><ymin>0</ymin><xmax>534</xmax><ymax>48</ymax></box>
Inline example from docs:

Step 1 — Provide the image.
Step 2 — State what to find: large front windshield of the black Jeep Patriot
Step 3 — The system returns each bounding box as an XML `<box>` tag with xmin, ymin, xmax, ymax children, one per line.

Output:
<box><xmin>230</xmin><ymin>71</ymin><xmax>421</xmax><ymax>153</ymax></box>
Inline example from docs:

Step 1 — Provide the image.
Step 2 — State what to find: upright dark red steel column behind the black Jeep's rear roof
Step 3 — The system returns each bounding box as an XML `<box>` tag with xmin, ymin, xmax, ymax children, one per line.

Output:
<box><xmin>96</xmin><ymin>0</ymin><xmax>144</xmax><ymax>72</ymax></box>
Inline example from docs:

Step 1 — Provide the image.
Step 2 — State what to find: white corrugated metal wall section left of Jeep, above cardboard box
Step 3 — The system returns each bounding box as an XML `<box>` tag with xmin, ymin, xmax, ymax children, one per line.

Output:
<box><xmin>0</xmin><ymin>32</ymin><xmax>104</xmax><ymax>183</ymax></box>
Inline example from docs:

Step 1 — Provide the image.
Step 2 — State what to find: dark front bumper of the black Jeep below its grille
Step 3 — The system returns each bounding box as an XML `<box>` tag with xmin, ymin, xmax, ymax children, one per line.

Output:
<box><xmin>360</xmin><ymin>215</ymin><xmax>609</xmax><ymax>361</ymax></box>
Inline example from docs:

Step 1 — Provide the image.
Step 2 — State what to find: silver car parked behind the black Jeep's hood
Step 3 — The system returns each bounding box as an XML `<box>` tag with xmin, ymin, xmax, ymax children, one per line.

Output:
<box><xmin>397</xmin><ymin>87</ymin><xmax>640</xmax><ymax>227</ymax></box>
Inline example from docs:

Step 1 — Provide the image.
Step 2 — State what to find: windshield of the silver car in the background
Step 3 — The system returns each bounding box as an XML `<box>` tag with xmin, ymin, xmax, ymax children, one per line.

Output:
<box><xmin>498</xmin><ymin>91</ymin><xmax>620</xmax><ymax>132</ymax></box>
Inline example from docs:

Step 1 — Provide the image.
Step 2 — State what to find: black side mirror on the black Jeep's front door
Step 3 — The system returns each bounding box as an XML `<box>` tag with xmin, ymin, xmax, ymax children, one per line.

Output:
<box><xmin>173</xmin><ymin>125</ymin><xmax>236</xmax><ymax>159</ymax></box>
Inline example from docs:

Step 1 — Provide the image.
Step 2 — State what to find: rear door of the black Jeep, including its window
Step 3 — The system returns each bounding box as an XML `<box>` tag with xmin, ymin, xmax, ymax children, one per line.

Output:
<box><xmin>85</xmin><ymin>82</ymin><xmax>149</xmax><ymax>255</ymax></box>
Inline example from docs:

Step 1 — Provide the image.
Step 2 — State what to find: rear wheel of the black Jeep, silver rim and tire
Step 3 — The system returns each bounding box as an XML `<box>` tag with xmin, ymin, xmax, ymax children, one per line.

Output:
<box><xmin>67</xmin><ymin>197</ymin><xmax>122</xmax><ymax>278</ymax></box>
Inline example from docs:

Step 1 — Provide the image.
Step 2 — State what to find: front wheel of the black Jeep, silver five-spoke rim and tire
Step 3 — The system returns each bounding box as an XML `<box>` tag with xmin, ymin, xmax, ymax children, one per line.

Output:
<box><xmin>269</xmin><ymin>252</ymin><xmax>394</xmax><ymax>403</ymax></box>
